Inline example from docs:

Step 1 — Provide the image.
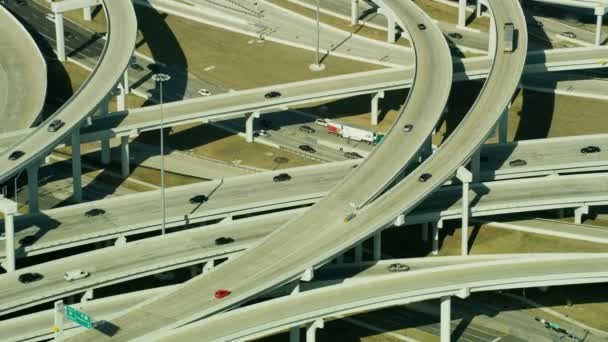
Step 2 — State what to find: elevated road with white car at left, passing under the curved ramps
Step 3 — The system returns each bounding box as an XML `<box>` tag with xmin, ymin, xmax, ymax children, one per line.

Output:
<box><xmin>0</xmin><ymin>174</ymin><xmax>608</xmax><ymax>314</ymax></box>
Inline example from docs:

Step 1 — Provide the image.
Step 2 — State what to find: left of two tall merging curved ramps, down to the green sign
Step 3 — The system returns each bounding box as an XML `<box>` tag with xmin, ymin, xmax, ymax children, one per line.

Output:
<box><xmin>65</xmin><ymin>0</ymin><xmax>452</xmax><ymax>341</ymax></box>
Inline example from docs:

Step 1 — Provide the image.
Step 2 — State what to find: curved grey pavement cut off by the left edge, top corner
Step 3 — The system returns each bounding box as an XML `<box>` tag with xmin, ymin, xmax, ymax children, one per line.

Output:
<box><xmin>0</xmin><ymin>6</ymin><xmax>47</xmax><ymax>134</ymax></box>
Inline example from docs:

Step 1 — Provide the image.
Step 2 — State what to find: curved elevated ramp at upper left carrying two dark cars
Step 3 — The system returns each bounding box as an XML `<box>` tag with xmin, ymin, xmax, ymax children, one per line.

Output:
<box><xmin>0</xmin><ymin>1</ymin><xmax>137</xmax><ymax>183</ymax></box>
